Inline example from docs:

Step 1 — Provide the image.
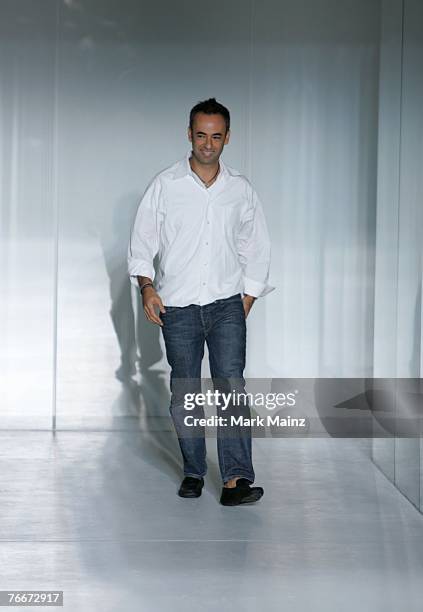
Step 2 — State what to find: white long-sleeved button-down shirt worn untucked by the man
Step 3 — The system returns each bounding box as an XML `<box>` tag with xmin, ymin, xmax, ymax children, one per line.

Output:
<box><xmin>128</xmin><ymin>151</ymin><xmax>274</xmax><ymax>306</ymax></box>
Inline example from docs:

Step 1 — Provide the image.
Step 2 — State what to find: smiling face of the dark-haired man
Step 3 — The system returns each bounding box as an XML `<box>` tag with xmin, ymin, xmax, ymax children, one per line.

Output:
<box><xmin>188</xmin><ymin>113</ymin><xmax>230</xmax><ymax>166</ymax></box>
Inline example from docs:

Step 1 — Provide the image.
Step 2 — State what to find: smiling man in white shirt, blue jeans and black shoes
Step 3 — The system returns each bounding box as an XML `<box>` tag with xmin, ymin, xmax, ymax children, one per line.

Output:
<box><xmin>128</xmin><ymin>98</ymin><xmax>273</xmax><ymax>505</ymax></box>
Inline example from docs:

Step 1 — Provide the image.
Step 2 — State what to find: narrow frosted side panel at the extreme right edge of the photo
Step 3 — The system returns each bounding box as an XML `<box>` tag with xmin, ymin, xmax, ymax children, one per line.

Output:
<box><xmin>395</xmin><ymin>0</ymin><xmax>423</xmax><ymax>509</ymax></box>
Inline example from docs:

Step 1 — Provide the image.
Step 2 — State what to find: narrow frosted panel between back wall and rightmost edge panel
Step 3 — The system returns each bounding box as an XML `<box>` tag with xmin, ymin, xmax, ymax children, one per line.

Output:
<box><xmin>370</xmin><ymin>0</ymin><xmax>403</xmax><ymax>482</ymax></box>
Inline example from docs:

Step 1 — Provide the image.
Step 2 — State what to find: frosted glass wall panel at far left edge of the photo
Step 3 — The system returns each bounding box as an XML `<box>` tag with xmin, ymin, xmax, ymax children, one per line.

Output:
<box><xmin>0</xmin><ymin>0</ymin><xmax>56</xmax><ymax>428</ymax></box>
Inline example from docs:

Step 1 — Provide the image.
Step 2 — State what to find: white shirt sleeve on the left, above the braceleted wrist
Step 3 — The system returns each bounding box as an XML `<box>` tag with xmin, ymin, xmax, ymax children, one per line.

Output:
<box><xmin>128</xmin><ymin>178</ymin><xmax>161</xmax><ymax>286</ymax></box>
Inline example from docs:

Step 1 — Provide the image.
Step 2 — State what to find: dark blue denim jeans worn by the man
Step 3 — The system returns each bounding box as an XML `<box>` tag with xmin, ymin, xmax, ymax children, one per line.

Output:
<box><xmin>160</xmin><ymin>293</ymin><xmax>255</xmax><ymax>483</ymax></box>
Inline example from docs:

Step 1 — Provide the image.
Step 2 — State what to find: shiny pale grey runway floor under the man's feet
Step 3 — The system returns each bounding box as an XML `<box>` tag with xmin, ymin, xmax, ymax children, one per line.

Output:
<box><xmin>0</xmin><ymin>431</ymin><xmax>423</xmax><ymax>612</ymax></box>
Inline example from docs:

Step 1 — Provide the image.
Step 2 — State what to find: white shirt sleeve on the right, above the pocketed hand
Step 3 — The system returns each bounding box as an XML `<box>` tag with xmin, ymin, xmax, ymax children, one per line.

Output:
<box><xmin>237</xmin><ymin>186</ymin><xmax>275</xmax><ymax>298</ymax></box>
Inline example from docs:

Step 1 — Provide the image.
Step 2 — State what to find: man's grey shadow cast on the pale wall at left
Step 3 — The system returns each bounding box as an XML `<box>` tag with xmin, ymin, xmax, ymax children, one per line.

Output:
<box><xmin>99</xmin><ymin>193</ymin><xmax>180</xmax><ymax>476</ymax></box>
